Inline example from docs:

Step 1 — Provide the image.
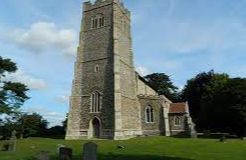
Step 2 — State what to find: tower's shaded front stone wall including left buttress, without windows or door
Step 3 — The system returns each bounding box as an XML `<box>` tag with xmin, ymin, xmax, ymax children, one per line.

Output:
<box><xmin>67</xmin><ymin>0</ymin><xmax>114</xmax><ymax>139</ymax></box>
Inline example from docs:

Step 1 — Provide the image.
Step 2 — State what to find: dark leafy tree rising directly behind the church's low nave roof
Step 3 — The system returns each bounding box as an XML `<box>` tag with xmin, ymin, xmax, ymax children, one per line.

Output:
<box><xmin>144</xmin><ymin>73</ymin><xmax>180</xmax><ymax>101</ymax></box>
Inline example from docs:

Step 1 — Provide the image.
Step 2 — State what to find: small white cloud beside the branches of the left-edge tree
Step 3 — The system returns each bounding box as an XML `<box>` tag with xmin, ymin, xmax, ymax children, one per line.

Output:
<box><xmin>4</xmin><ymin>70</ymin><xmax>47</xmax><ymax>90</ymax></box>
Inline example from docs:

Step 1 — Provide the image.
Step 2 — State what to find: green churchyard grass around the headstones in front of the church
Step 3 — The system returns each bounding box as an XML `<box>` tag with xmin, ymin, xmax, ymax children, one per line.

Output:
<box><xmin>0</xmin><ymin>137</ymin><xmax>246</xmax><ymax>160</ymax></box>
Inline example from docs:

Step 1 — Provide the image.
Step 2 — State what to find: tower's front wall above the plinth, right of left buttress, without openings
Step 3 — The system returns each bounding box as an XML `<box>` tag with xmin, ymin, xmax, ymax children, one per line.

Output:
<box><xmin>81</xmin><ymin>3</ymin><xmax>114</xmax><ymax>130</ymax></box>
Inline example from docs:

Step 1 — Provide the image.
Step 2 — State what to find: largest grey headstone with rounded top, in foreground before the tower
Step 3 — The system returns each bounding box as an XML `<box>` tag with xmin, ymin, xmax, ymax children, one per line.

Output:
<box><xmin>83</xmin><ymin>142</ymin><xmax>97</xmax><ymax>160</ymax></box>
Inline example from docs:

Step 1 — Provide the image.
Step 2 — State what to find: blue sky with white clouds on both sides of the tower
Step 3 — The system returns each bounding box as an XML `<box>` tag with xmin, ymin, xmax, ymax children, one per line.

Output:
<box><xmin>0</xmin><ymin>0</ymin><xmax>246</xmax><ymax>126</ymax></box>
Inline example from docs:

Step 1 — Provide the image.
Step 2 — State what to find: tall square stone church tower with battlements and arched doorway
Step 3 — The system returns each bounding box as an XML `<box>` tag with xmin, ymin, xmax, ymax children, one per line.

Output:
<box><xmin>66</xmin><ymin>0</ymin><xmax>141</xmax><ymax>139</ymax></box>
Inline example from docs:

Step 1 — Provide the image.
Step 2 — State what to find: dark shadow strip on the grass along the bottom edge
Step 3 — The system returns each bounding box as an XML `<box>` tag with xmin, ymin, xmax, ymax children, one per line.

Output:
<box><xmin>47</xmin><ymin>154</ymin><xmax>193</xmax><ymax>160</ymax></box>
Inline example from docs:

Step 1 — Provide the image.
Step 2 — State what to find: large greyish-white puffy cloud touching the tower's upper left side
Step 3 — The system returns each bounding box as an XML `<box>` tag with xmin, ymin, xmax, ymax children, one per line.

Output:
<box><xmin>8</xmin><ymin>22</ymin><xmax>76</xmax><ymax>56</ymax></box>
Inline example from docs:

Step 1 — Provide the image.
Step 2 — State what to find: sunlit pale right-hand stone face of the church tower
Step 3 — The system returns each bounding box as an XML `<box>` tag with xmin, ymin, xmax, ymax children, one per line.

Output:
<box><xmin>114</xmin><ymin>0</ymin><xmax>141</xmax><ymax>139</ymax></box>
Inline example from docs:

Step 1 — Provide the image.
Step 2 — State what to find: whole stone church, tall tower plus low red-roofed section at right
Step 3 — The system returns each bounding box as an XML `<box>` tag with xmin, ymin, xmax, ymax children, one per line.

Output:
<box><xmin>66</xmin><ymin>0</ymin><xmax>196</xmax><ymax>140</ymax></box>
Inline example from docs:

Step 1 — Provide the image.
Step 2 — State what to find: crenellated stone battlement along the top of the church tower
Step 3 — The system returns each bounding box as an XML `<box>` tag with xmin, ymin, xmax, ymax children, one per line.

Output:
<box><xmin>83</xmin><ymin>0</ymin><xmax>130</xmax><ymax>15</ymax></box>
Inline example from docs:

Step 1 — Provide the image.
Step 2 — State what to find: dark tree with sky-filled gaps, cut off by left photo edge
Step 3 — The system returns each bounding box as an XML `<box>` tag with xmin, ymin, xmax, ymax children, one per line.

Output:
<box><xmin>0</xmin><ymin>56</ymin><xmax>29</xmax><ymax>115</ymax></box>
